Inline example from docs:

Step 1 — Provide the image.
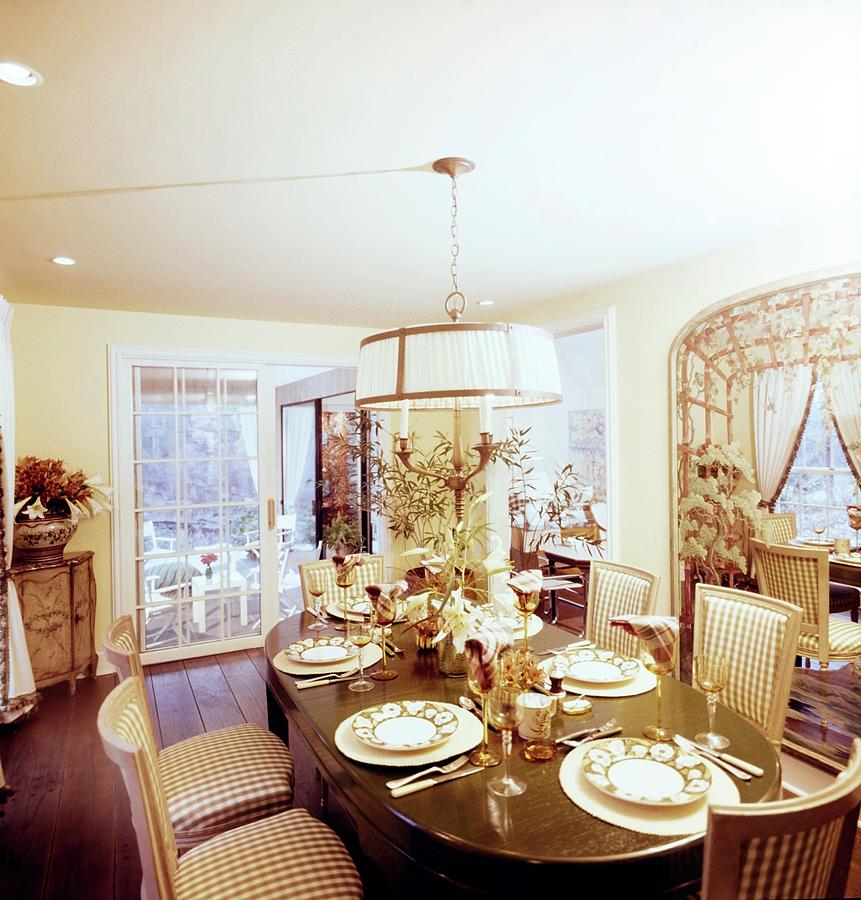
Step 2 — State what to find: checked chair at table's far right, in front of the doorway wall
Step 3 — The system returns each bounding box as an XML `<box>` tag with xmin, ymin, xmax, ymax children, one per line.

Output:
<box><xmin>586</xmin><ymin>560</ymin><xmax>660</xmax><ymax>656</ymax></box>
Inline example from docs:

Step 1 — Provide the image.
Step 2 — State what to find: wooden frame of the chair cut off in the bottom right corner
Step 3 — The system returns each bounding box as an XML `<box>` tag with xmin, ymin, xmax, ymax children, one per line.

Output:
<box><xmin>702</xmin><ymin>738</ymin><xmax>861</xmax><ymax>900</ymax></box>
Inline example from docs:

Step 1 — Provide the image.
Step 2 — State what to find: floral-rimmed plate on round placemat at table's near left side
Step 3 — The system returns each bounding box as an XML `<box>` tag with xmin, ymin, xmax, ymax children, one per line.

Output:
<box><xmin>352</xmin><ymin>700</ymin><xmax>458</xmax><ymax>750</ymax></box>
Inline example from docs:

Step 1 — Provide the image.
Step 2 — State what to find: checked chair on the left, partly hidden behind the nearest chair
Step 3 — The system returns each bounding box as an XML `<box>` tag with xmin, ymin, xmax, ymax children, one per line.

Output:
<box><xmin>103</xmin><ymin>616</ymin><xmax>293</xmax><ymax>849</ymax></box>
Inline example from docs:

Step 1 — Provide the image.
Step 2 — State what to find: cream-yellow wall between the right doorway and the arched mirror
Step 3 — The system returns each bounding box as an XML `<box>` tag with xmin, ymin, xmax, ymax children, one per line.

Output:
<box><xmin>512</xmin><ymin>215</ymin><xmax>861</xmax><ymax>611</ymax></box>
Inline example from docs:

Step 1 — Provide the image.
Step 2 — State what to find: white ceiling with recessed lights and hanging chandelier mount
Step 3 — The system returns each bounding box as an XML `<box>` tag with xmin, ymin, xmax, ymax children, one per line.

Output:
<box><xmin>0</xmin><ymin>0</ymin><xmax>861</xmax><ymax>327</ymax></box>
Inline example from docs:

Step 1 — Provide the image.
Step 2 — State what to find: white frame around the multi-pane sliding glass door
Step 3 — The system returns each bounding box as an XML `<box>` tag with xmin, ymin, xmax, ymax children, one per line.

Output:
<box><xmin>108</xmin><ymin>345</ymin><xmax>358</xmax><ymax>663</ymax></box>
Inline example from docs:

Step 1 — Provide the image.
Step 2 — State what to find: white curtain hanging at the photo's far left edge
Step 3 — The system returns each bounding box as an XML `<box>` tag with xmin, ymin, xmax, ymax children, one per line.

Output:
<box><xmin>0</xmin><ymin>297</ymin><xmax>36</xmax><ymax>722</ymax></box>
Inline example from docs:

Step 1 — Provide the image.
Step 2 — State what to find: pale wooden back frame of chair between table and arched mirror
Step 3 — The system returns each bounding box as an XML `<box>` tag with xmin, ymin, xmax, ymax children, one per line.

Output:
<box><xmin>694</xmin><ymin>584</ymin><xmax>802</xmax><ymax>748</ymax></box>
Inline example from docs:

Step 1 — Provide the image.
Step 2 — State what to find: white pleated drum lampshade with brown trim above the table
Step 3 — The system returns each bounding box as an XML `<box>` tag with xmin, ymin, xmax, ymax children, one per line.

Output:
<box><xmin>356</xmin><ymin>322</ymin><xmax>562</xmax><ymax>409</ymax></box>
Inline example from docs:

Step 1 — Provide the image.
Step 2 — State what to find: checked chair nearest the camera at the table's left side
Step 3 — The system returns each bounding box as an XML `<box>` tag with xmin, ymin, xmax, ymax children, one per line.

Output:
<box><xmin>98</xmin><ymin>677</ymin><xmax>362</xmax><ymax>900</ymax></box>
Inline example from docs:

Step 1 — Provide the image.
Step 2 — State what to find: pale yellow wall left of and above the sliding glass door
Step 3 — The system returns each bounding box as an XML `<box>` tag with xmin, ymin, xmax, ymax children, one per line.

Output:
<box><xmin>12</xmin><ymin>304</ymin><xmax>366</xmax><ymax>639</ymax></box>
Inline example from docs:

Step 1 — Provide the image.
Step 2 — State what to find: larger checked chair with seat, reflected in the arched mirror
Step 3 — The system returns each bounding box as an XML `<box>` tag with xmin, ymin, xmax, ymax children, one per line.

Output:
<box><xmin>750</xmin><ymin>541</ymin><xmax>861</xmax><ymax>669</ymax></box>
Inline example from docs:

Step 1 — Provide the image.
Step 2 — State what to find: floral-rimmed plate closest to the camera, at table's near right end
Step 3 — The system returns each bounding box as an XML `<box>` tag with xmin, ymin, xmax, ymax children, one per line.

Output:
<box><xmin>580</xmin><ymin>738</ymin><xmax>712</xmax><ymax>806</ymax></box>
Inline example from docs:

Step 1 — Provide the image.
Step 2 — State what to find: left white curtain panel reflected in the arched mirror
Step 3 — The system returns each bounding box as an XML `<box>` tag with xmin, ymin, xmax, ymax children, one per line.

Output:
<box><xmin>753</xmin><ymin>366</ymin><xmax>813</xmax><ymax>504</ymax></box>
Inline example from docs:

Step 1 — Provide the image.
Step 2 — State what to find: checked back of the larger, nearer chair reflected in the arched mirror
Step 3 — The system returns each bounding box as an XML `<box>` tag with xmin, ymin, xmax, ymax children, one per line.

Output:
<box><xmin>750</xmin><ymin>541</ymin><xmax>829</xmax><ymax>662</ymax></box>
